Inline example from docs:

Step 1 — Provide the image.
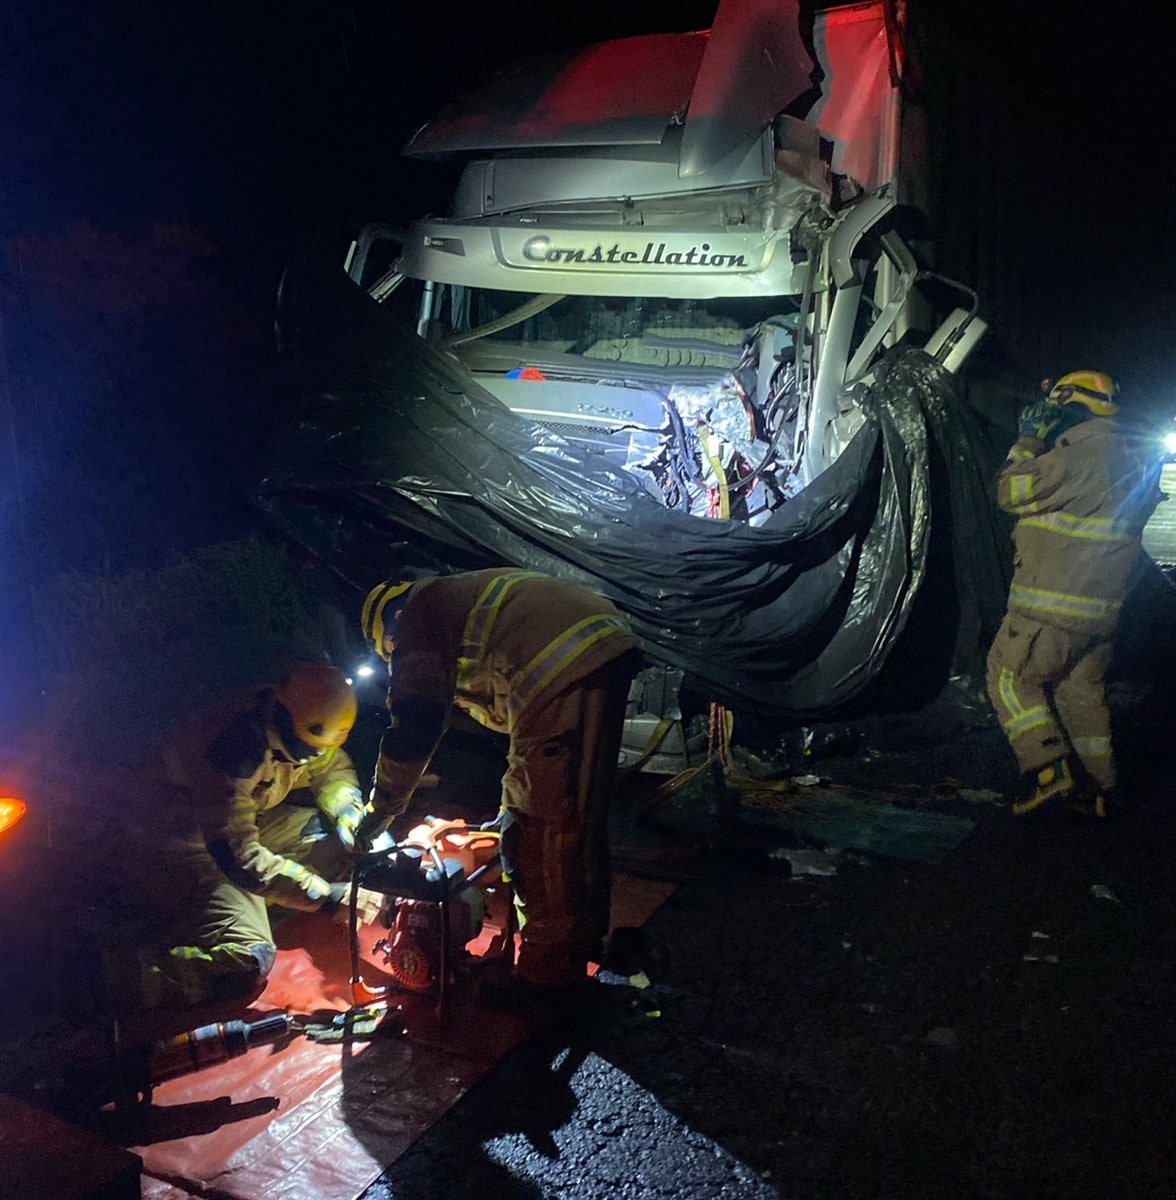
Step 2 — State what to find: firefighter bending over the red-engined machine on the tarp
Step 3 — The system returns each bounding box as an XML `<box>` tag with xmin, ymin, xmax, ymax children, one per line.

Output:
<box><xmin>361</xmin><ymin>569</ymin><xmax>637</xmax><ymax>1007</ymax></box>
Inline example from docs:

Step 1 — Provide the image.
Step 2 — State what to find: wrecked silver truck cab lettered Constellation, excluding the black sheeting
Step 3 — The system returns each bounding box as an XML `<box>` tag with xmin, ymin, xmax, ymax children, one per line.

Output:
<box><xmin>347</xmin><ymin>4</ymin><xmax>984</xmax><ymax>523</ymax></box>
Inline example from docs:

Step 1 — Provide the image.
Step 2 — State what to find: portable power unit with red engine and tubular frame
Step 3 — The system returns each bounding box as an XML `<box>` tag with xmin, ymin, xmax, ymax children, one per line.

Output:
<box><xmin>348</xmin><ymin>817</ymin><xmax>515</xmax><ymax>1015</ymax></box>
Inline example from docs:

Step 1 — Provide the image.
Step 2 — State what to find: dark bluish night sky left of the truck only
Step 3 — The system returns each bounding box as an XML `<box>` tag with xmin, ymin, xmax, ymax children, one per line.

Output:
<box><xmin>0</xmin><ymin>0</ymin><xmax>713</xmax><ymax>571</ymax></box>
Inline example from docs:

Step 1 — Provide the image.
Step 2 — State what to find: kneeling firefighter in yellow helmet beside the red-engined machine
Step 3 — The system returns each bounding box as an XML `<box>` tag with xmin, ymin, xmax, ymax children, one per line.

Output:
<box><xmin>108</xmin><ymin>662</ymin><xmax>379</xmax><ymax>1007</ymax></box>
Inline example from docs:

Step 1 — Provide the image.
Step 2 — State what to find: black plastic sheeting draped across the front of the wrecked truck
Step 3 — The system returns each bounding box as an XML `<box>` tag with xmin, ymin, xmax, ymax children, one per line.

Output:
<box><xmin>258</xmin><ymin>252</ymin><xmax>990</xmax><ymax>716</ymax></box>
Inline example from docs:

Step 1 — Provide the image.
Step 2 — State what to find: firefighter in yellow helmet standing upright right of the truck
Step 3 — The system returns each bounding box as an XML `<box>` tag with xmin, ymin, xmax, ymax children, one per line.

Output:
<box><xmin>988</xmin><ymin>371</ymin><xmax>1156</xmax><ymax>817</ymax></box>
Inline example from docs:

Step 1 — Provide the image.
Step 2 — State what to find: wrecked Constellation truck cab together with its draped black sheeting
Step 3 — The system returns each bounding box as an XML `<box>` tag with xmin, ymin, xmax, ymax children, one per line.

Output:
<box><xmin>260</xmin><ymin>0</ymin><xmax>991</xmax><ymax>739</ymax></box>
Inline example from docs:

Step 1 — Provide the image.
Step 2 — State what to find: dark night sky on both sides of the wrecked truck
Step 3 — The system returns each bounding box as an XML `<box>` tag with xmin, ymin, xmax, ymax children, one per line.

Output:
<box><xmin>0</xmin><ymin>0</ymin><xmax>1176</xmax><ymax>580</ymax></box>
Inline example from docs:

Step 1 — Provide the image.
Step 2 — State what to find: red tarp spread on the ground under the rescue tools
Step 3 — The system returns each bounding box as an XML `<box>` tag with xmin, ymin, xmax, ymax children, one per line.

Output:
<box><xmin>132</xmin><ymin>875</ymin><xmax>673</xmax><ymax>1200</ymax></box>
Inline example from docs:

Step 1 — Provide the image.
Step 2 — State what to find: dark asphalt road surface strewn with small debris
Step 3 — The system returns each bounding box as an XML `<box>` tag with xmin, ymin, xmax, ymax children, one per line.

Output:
<box><xmin>364</xmin><ymin>576</ymin><xmax>1176</xmax><ymax>1200</ymax></box>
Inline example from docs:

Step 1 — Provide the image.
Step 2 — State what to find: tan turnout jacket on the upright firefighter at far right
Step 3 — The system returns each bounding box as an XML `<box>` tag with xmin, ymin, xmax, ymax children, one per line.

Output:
<box><xmin>997</xmin><ymin>416</ymin><xmax>1158</xmax><ymax>635</ymax></box>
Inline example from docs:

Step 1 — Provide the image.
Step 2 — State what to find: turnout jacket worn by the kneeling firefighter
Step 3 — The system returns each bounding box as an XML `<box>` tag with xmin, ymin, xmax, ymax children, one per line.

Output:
<box><xmin>158</xmin><ymin>689</ymin><xmax>361</xmax><ymax>910</ymax></box>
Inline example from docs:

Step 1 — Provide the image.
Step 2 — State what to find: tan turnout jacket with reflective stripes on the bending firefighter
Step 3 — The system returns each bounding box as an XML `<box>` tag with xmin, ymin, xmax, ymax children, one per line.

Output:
<box><xmin>376</xmin><ymin>568</ymin><xmax>636</xmax><ymax>812</ymax></box>
